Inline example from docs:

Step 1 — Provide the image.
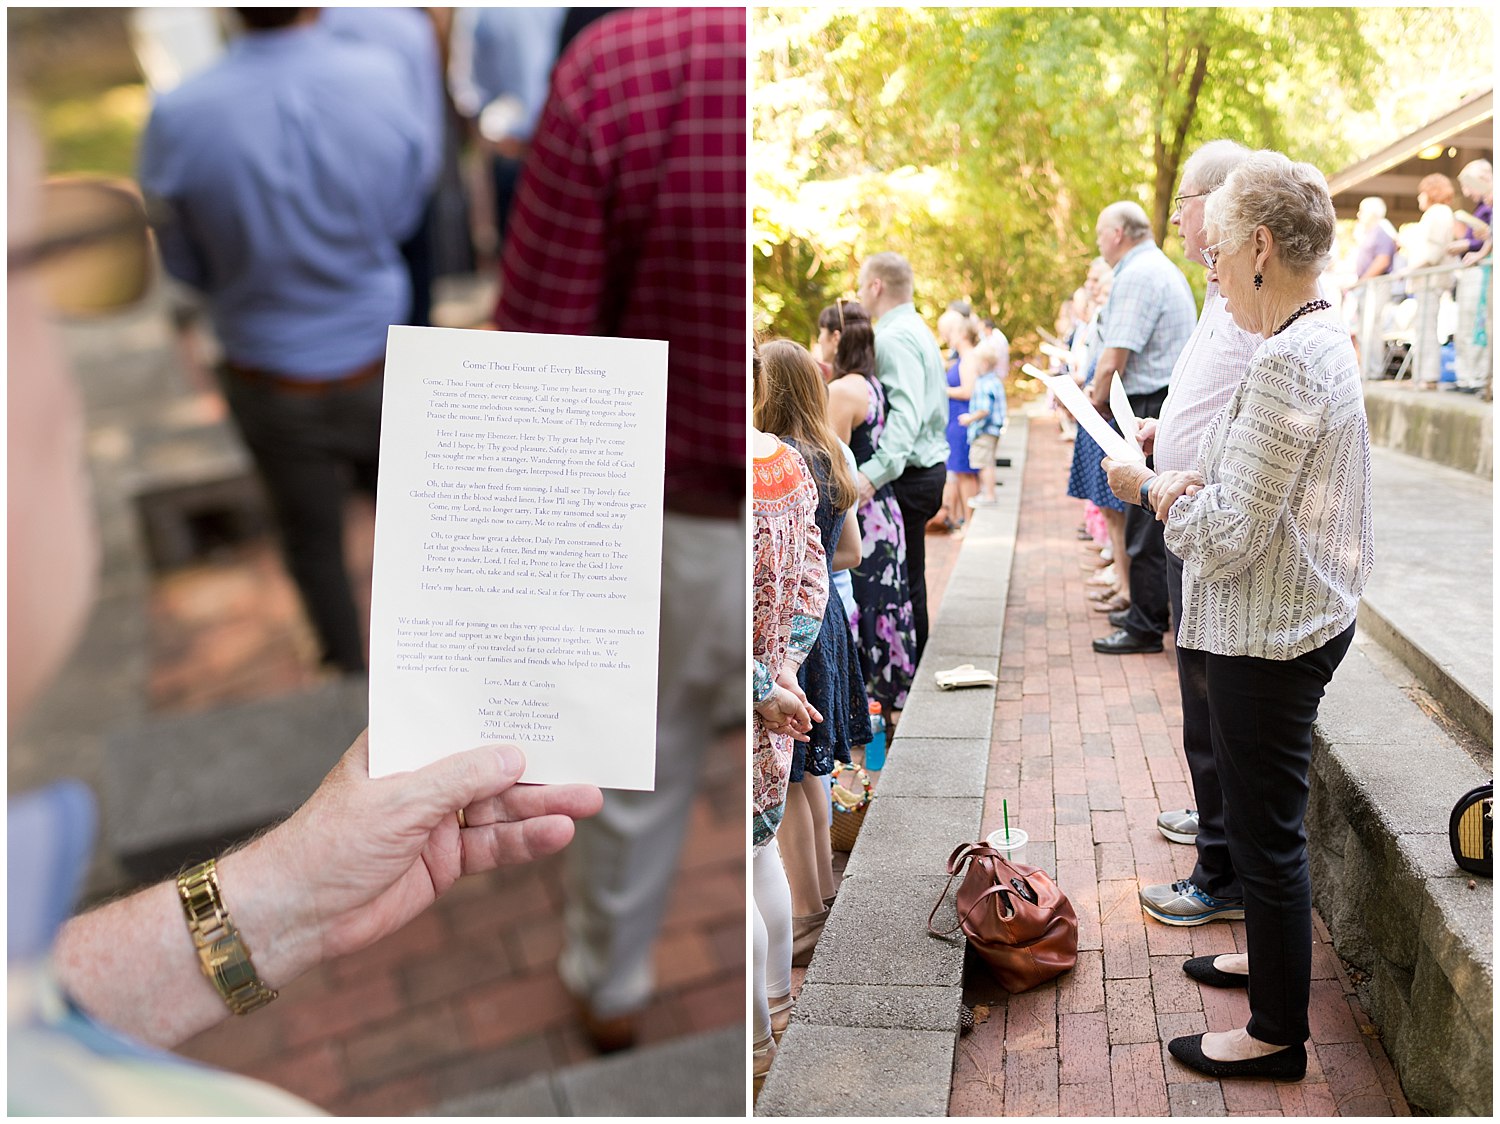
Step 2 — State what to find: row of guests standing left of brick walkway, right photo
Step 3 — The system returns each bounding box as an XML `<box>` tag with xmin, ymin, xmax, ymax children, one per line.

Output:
<box><xmin>752</xmin><ymin>254</ymin><xmax>1008</xmax><ymax>1089</ymax></box>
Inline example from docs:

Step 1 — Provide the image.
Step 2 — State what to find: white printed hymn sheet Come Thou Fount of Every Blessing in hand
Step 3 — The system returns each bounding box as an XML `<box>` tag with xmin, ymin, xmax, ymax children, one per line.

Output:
<box><xmin>369</xmin><ymin>327</ymin><xmax>666</xmax><ymax>789</ymax></box>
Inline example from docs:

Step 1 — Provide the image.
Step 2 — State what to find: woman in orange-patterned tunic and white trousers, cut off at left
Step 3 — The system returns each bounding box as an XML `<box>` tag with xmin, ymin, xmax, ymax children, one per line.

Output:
<box><xmin>752</xmin><ymin>357</ymin><xmax>828</xmax><ymax>1092</ymax></box>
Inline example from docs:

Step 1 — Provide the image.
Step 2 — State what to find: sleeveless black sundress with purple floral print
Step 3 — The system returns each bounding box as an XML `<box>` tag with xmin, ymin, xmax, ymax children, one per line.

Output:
<box><xmin>849</xmin><ymin>375</ymin><xmax>917</xmax><ymax>714</ymax></box>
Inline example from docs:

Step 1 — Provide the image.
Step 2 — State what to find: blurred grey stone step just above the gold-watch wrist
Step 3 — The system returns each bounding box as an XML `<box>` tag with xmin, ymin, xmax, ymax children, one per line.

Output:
<box><xmin>104</xmin><ymin>677</ymin><xmax>369</xmax><ymax>881</ymax></box>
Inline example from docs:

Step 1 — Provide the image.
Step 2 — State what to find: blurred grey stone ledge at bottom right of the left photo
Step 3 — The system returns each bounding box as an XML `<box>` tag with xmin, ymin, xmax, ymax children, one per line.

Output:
<box><xmin>422</xmin><ymin>1026</ymin><xmax>749</xmax><ymax>1118</ymax></box>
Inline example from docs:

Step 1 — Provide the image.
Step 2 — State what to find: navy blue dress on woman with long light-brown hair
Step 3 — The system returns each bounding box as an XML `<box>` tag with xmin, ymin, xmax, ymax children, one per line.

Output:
<box><xmin>788</xmin><ymin>441</ymin><xmax>873</xmax><ymax>783</ymax></box>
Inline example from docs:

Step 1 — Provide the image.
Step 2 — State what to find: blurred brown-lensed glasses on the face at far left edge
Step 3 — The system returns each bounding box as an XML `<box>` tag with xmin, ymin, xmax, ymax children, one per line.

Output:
<box><xmin>6</xmin><ymin>176</ymin><xmax>152</xmax><ymax>317</ymax></box>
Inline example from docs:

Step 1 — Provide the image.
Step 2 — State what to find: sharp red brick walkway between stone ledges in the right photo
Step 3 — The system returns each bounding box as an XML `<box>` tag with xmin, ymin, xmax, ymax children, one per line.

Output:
<box><xmin>950</xmin><ymin>417</ymin><xmax>1410</xmax><ymax>1116</ymax></box>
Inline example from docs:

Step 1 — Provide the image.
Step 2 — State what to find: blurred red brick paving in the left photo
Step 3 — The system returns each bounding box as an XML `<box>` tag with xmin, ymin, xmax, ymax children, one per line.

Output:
<box><xmin>161</xmin><ymin>510</ymin><xmax>746</xmax><ymax>1115</ymax></box>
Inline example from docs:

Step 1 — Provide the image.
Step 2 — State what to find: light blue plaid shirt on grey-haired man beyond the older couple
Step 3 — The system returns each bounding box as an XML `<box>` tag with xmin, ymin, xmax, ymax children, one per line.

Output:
<box><xmin>1100</xmin><ymin>239</ymin><xmax>1199</xmax><ymax>395</ymax></box>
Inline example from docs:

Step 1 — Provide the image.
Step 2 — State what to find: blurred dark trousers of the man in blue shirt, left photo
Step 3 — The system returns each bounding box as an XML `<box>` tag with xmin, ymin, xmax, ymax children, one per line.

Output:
<box><xmin>222</xmin><ymin>372</ymin><xmax>383</xmax><ymax>671</ymax></box>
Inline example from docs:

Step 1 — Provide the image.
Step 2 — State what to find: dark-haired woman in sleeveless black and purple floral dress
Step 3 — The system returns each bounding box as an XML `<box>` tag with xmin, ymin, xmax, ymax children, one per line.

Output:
<box><xmin>828</xmin><ymin>303</ymin><xmax>921</xmax><ymax>729</ymax></box>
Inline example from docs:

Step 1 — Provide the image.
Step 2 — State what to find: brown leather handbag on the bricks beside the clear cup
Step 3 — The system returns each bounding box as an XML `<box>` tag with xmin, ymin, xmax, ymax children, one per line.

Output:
<box><xmin>927</xmin><ymin>843</ymin><xmax>1079</xmax><ymax>992</ymax></box>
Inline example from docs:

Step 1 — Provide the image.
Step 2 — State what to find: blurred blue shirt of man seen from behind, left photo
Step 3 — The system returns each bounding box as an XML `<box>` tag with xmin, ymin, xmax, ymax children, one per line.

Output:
<box><xmin>141</xmin><ymin>24</ymin><xmax>432</xmax><ymax>378</ymax></box>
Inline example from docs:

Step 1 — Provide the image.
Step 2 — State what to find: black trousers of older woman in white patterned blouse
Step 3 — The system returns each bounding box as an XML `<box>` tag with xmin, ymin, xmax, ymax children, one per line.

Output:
<box><xmin>1205</xmin><ymin>624</ymin><xmax>1355</xmax><ymax>1046</ymax></box>
